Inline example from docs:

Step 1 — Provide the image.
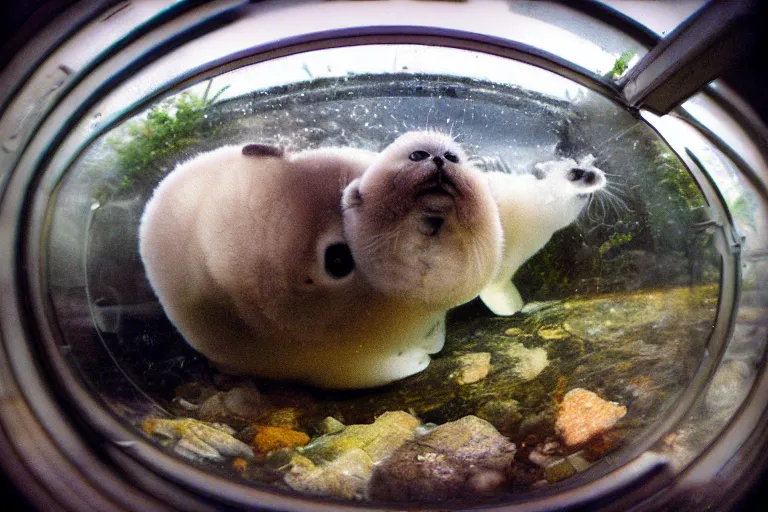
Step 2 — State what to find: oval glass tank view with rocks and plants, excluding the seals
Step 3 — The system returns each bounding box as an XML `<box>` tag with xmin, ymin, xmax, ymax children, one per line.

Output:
<box><xmin>40</xmin><ymin>44</ymin><xmax>736</xmax><ymax>503</ymax></box>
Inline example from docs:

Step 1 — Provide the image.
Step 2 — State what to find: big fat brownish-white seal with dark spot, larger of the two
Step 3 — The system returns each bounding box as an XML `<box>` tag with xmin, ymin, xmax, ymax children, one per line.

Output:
<box><xmin>139</xmin><ymin>134</ymin><xmax>501</xmax><ymax>388</ymax></box>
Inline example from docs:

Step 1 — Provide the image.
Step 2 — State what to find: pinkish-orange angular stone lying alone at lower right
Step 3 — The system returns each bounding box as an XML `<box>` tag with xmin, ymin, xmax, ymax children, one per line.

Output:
<box><xmin>555</xmin><ymin>388</ymin><xmax>627</xmax><ymax>447</ymax></box>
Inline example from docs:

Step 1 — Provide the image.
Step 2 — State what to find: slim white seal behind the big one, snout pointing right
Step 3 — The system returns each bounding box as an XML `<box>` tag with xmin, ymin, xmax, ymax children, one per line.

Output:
<box><xmin>480</xmin><ymin>155</ymin><xmax>606</xmax><ymax>316</ymax></box>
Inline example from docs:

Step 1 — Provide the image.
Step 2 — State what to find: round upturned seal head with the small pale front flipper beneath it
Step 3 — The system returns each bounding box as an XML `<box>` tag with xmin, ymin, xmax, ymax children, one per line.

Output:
<box><xmin>342</xmin><ymin>131</ymin><xmax>503</xmax><ymax>378</ymax></box>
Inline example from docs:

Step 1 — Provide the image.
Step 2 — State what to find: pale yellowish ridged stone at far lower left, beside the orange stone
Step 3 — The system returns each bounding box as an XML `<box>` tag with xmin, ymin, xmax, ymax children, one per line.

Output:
<box><xmin>141</xmin><ymin>418</ymin><xmax>254</xmax><ymax>462</ymax></box>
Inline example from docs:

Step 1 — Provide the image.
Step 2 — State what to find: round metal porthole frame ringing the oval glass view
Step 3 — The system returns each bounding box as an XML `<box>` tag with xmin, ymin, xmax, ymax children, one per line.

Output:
<box><xmin>0</xmin><ymin>2</ymin><xmax>768</xmax><ymax>511</ymax></box>
